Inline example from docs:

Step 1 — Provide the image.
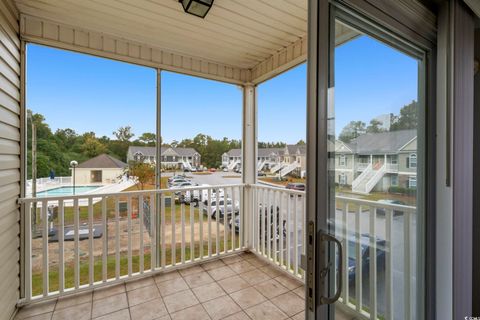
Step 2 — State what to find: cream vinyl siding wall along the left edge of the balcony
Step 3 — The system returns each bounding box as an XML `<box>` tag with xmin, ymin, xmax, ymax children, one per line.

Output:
<box><xmin>0</xmin><ymin>0</ymin><xmax>20</xmax><ymax>319</ymax></box>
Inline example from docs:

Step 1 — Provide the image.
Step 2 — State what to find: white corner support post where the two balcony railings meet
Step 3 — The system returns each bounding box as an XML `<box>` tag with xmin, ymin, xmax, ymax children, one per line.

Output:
<box><xmin>240</xmin><ymin>85</ymin><xmax>257</xmax><ymax>248</ymax></box>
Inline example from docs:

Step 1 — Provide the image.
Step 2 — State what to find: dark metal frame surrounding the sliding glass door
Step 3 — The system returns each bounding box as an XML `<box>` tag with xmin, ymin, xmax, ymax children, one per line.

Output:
<box><xmin>305</xmin><ymin>0</ymin><xmax>436</xmax><ymax>319</ymax></box>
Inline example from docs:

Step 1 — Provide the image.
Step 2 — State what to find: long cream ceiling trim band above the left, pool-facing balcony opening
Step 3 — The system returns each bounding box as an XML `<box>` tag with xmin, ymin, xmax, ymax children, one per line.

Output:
<box><xmin>20</xmin><ymin>14</ymin><xmax>251</xmax><ymax>84</ymax></box>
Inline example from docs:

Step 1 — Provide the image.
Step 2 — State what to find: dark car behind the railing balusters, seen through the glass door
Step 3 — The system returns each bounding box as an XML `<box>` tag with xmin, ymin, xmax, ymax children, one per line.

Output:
<box><xmin>344</xmin><ymin>234</ymin><xmax>386</xmax><ymax>282</ymax></box>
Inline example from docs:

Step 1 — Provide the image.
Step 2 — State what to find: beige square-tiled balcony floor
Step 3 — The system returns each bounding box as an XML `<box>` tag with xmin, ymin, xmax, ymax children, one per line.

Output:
<box><xmin>15</xmin><ymin>253</ymin><xmax>304</xmax><ymax>320</ymax></box>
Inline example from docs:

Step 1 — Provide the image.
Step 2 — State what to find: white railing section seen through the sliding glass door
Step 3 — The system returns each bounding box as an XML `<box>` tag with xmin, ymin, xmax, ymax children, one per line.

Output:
<box><xmin>335</xmin><ymin>197</ymin><xmax>416</xmax><ymax>319</ymax></box>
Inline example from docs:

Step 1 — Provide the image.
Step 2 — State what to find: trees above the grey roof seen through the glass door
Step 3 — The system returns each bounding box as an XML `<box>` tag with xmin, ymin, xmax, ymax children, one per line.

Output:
<box><xmin>338</xmin><ymin>101</ymin><xmax>418</xmax><ymax>143</ymax></box>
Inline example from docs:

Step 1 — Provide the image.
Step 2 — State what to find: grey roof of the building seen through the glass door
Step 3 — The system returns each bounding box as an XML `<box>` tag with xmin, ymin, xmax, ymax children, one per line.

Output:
<box><xmin>345</xmin><ymin>130</ymin><xmax>417</xmax><ymax>154</ymax></box>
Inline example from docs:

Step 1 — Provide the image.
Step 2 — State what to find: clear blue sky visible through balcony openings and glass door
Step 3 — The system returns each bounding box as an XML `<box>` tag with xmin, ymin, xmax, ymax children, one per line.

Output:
<box><xmin>27</xmin><ymin>37</ymin><xmax>417</xmax><ymax>143</ymax></box>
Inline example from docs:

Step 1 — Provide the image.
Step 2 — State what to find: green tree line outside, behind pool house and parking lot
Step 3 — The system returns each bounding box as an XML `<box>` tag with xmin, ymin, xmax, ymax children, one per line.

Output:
<box><xmin>27</xmin><ymin>110</ymin><xmax>305</xmax><ymax>179</ymax></box>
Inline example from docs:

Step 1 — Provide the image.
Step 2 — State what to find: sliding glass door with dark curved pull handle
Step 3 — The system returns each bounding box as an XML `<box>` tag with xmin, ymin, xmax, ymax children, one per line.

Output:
<box><xmin>307</xmin><ymin>1</ymin><xmax>426</xmax><ymax>319</ymax></box>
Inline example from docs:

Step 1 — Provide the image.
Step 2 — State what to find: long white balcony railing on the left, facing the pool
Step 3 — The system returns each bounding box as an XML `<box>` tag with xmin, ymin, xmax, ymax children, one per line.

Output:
<box><xmin>20</xmin><ymin>184</ymin><xmax>244</xmax><ymax>302</ymax></box>
